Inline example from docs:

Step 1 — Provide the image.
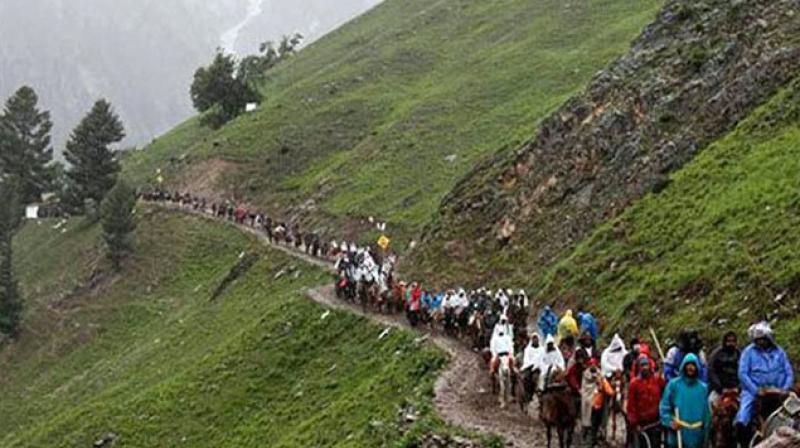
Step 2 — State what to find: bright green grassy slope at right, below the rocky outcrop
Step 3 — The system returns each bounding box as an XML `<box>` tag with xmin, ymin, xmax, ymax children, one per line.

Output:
<box><xmin>537</xmin><ymin>79</ymin><xmax>800</xmax><ymax>360</ymax></box>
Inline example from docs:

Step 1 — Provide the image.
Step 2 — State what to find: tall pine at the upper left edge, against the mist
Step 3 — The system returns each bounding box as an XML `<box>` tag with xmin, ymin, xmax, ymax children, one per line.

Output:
<box><xmin>0</xmin><ymin>86</ymin><xmax>53</xmax><ymax>203</ymax></box>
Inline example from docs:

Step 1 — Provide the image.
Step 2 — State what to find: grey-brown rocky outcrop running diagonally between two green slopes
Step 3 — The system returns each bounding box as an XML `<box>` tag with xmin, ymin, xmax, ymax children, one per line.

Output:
<box><xmin>409</xmin><ymin>0</ymin><xmax>800</xmax><ymax>284</ymax></box>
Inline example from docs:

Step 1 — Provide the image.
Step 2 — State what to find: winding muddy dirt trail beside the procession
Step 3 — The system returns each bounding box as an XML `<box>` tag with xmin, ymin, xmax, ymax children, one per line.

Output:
<box><xmin>159</xmin><ymin>204</ymin><xmax>546</xmax><ymax>448</ymax></box>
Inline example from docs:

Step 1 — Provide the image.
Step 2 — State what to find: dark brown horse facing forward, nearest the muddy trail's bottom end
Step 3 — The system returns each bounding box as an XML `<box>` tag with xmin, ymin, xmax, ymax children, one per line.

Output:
<box><xmin>539</xmin><ymin>370</ymin><xmax>578</xmax><ymax>448</ymax></box>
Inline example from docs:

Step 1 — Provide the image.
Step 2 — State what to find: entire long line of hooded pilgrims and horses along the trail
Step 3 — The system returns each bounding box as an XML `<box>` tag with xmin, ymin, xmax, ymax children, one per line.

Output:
<box><xmin>140</xmin><ymin>190</ymin><xmax>800</xmax><ymax>448</ymax></box>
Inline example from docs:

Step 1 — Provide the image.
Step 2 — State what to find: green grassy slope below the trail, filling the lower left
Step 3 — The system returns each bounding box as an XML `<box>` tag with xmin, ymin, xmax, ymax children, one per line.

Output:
<box><xmin>0</xmin><ymin>209</ymin><xmax>456</xmax><ymax>448</ymax></box>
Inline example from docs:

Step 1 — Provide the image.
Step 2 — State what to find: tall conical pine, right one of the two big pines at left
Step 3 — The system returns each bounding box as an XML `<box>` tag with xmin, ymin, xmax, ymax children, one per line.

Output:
<box><xmin>64</xmin><ymin>100</ymin><xmax>125</xmax><ymax>204</ymax></box>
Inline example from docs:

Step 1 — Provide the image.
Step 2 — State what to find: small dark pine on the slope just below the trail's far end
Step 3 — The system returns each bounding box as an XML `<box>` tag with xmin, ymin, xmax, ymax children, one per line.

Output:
<box><xmin>100</xmin><ymin>180</ymin><xmax>136</xmax><ymax>271</ymax></box>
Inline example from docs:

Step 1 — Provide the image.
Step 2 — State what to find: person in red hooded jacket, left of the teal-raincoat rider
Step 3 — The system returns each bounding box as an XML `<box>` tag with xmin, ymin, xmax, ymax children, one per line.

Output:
<box><xmin>627</xmin><ymin>355</ymin><xmax>665</xmax><ymax>448</ymax></box>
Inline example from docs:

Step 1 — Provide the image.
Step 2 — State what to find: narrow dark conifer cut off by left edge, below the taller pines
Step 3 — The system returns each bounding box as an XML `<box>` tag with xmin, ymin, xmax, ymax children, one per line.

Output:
<box><xmin>0</xmin><ymin>181</ymin><xmax>22</xmax><ymax>338</ymax></box>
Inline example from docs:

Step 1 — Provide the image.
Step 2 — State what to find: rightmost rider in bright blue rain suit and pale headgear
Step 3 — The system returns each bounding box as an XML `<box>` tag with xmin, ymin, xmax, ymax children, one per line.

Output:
<box><xmin>735</xmin><ymin>322</ymin><xmax>794</xmax><ymax>440</ymax></box>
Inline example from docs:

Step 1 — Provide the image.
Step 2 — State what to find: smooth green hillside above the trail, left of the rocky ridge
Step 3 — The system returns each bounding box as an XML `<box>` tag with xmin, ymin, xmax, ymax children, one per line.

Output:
<box><xmin>125</xmin><ymin>0</ymin><xmax>662</xmax><ymax>242</ymax></box>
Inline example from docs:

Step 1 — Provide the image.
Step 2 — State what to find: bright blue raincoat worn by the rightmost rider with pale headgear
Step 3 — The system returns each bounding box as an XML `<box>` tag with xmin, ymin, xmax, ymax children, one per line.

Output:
<box><xmin>736</xmin><ymin>344</ymin><xmax>794</xmax><ymax>425</ymax></box>
